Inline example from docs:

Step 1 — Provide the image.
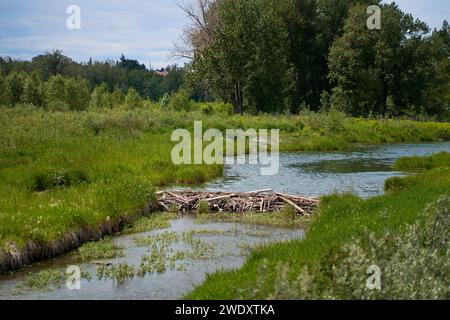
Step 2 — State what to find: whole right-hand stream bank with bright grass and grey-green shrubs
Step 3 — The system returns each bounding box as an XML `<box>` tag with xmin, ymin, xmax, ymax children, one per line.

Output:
<box><xmin>186</xmin><ymin>153</ymin><xmax>450</xmax><ymax>299</ymax></box>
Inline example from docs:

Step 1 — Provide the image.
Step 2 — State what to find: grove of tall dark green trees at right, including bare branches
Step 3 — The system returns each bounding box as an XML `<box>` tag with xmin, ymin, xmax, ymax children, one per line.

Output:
<box><xmin>177</xmin><ymin>0</ymin><xmax>450</xmax><ymax>117</ymax></box>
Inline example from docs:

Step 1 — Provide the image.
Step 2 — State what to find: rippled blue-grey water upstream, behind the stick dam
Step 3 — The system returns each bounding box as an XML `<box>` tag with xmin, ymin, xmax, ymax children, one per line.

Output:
<box><xmin>206</xmin><ymin>142</ymin><xmax>450</xmax><ymax>198</ymax></box>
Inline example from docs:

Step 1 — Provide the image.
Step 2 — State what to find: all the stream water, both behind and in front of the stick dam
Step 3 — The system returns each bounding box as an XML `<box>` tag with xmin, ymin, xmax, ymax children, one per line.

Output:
<box><xmin>0</xmin><ymin>142</ymin><xmax>450</xmax><ymax>299</ymax></box>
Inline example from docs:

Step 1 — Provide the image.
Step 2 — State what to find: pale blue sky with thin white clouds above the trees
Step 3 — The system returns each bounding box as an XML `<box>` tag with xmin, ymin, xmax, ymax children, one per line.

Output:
<box><xmin>0</xmin><ymin>0</ymin><xmax>450</xmax><ymax>68</ymax></box>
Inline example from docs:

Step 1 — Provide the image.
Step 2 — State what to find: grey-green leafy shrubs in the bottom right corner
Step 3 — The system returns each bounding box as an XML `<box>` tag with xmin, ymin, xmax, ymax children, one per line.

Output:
<box><xmin>250</xmin><ymin>196</ymin><xmax>450</xmax><ymax>300</ymax></box>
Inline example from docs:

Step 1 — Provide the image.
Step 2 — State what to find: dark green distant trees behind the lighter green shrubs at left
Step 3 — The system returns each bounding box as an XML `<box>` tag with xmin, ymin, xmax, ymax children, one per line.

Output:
<box><xmin>0</xmin><ymin>50</ymin><xmax>184</xmax><ymax>105</ymax></box>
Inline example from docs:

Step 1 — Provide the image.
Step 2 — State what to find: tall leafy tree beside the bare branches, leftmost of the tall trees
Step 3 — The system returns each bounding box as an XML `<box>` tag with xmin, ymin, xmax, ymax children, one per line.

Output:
<box><xmin>191</xmin><ymin>0</ymin><xmax>292</xmax><ymax>113</ymax></box>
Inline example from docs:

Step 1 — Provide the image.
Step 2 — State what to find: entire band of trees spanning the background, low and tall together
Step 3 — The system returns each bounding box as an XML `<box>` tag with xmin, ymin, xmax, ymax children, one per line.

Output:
<box><xmin>0</xmin><ymin>0</ymin><xmax>450</xmax><ymax>120</ymax></box>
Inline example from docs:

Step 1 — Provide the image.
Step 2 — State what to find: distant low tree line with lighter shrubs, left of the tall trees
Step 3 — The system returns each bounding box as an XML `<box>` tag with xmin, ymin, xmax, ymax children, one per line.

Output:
<box><xmin>0</xmin><ymin>50</ymin><xmax>185</xmax><ymax>110</ymax></box>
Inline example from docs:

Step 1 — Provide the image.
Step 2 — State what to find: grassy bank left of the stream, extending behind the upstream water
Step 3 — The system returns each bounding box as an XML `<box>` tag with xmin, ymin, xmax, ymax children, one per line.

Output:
<box><xmin>0</xmin><ymin>105</ymin><xmax>450</xmax><ymax>270</ymax></box>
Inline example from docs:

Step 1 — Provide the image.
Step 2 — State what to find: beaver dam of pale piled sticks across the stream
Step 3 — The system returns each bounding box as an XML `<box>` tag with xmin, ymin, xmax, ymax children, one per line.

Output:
<box><xmin>157</xmin><ymin>189</ymin><xmax>319</xmax><ymax>216</ymax></box>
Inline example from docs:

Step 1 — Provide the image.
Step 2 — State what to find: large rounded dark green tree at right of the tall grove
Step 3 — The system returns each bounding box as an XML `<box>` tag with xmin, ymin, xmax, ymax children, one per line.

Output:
<box><xmin>329</xmin><ymin>4</ymin><xmax>428</xmax><ymax>115</ymax></box>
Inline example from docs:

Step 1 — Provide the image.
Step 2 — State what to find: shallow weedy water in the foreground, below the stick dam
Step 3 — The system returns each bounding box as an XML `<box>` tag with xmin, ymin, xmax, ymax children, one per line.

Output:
<box><xmin>0</xmin><ymin>217</ymin><xmax>304</xmax><ymax>300</ymax></box>
